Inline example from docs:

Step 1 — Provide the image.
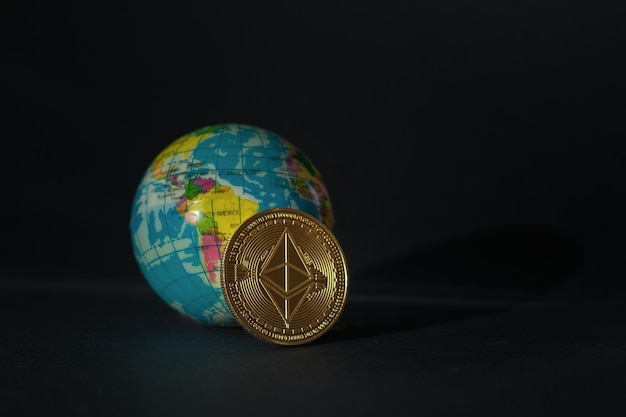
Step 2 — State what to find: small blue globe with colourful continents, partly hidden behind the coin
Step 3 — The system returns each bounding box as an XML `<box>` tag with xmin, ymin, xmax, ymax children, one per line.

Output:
<box><xmin>130</xmin><ymin>123</ymin><xmax>333</xmax><ymax>326</ymax></box>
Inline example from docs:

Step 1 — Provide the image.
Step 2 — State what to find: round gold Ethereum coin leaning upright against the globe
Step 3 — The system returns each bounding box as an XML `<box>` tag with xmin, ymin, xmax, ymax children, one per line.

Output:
<box><xmin>221</xmin><ymin>208</ymin><xmax>348</xmax><ymax>345</ymax></box>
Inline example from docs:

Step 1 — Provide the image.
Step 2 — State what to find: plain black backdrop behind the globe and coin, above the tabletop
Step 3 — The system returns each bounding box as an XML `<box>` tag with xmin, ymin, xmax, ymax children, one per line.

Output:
<box><xmin>0</xmin><ymin>0</ymin><xmax>626</xmax><ymax>415</ymax></box>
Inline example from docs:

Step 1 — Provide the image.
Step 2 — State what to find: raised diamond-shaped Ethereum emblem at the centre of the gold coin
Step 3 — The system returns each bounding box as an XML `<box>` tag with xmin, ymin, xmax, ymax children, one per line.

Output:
<box><xmin>259</xmin><ymin>229</ymin><xmax>313</xmax><ymax>325</ymax></box>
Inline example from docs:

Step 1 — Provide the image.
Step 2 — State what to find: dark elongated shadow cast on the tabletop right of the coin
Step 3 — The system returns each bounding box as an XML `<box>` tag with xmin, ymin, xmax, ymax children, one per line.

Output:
<box><xmin>324</xmin><ymin>229</ymin><xmax>583</xmax><ymax>341</ymax></box>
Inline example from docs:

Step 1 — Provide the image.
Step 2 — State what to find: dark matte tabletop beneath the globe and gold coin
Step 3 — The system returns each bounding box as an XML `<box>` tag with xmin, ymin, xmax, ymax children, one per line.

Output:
<box><xmin>0</xmin><ymin>244</ymin><xmax>626</xmax><ymax>416</ymax></box>
